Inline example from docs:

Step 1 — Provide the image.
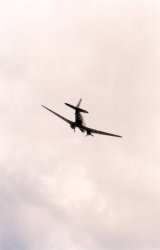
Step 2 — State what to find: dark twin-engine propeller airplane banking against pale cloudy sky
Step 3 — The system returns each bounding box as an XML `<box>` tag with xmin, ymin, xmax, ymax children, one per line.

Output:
<box><xmin>41</xmin><ymin>99</ymin><xmax>122</xmax><ymax>137</ymax></box>
